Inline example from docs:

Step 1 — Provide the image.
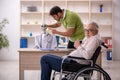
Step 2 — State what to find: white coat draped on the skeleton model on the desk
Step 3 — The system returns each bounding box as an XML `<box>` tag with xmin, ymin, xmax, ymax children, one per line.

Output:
<box><xmin>34</xmin><ymin>33</ymin><xmax>57</xmax><ymax>50</ymax></box>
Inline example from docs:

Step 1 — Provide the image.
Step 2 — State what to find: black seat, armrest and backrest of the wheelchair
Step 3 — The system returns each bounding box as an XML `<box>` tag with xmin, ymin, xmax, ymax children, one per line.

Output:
<box><xmin>62</xmin><ymin>46</ymin><xmax>101</xmax><ymax>72</ymax></box>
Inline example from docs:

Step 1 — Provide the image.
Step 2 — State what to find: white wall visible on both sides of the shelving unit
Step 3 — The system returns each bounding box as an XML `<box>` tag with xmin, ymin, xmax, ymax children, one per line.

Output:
<box><xmin>0</xmin><ymin>0</ymin><xmax>120</xmax><ymax>60</ymax></box>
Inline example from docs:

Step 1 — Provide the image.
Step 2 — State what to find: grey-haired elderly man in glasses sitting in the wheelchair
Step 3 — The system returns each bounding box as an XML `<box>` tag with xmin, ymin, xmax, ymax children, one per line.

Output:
<box><xmin>41</xmin><ymin>22</ymin><xmax>101</xmax><ymax>80</ymax></box>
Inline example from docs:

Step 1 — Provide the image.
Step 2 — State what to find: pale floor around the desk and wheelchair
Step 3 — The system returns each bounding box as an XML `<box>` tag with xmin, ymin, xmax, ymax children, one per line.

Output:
<box><xmin>0</xmin><ymin>52</ymin><xmax>120</xmax><ymax>80</ymax></box>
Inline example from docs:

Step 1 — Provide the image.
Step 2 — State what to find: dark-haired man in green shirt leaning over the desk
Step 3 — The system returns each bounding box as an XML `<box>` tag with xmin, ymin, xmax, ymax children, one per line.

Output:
<box><xmin>47</xmin><ymin>6</ymin><xmax>85</xmax><ymax>48</ymax></box>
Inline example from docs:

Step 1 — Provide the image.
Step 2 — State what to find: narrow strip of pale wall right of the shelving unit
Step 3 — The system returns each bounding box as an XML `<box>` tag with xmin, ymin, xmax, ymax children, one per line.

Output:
<box><xmin>112</xmin><ymin>0</ymin><xmax>120</xmax><ymax>60</ymax></box>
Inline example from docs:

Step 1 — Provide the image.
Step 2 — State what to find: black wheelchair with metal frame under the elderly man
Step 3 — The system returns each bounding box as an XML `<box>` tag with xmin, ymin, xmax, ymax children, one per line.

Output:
<box><xmin>52</xmin><ymin>43</ymin><xmax>111</xmax><ymax>80</ymax></box>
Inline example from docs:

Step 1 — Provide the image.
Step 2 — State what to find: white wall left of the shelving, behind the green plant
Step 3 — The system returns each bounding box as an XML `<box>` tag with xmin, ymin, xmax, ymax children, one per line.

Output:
<box><xmin>0</xmin><ymin>0</ymin><xmax>20</xmax><ymax>60</ymax></box>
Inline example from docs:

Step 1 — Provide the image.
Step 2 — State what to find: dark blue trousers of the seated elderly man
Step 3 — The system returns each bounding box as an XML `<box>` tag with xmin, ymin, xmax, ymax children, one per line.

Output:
<box><xmin>40</xmin><ymin>54</ymin><xmax>71</xmax><ymax>80</ymax></box>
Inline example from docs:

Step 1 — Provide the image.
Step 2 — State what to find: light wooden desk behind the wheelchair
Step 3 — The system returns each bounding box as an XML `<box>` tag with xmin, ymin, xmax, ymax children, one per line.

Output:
<box><xmin>18</xmin><ymin>48</ymin><xmax>101</xmax><ymax>80</ymax></box>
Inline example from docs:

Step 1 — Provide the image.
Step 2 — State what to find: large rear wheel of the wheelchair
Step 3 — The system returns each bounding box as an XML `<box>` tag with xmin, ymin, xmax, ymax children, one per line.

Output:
<box><xmin>72</xmin><ymin>67</ymin><xmax>111</xmax><ymax>80</ymax></box>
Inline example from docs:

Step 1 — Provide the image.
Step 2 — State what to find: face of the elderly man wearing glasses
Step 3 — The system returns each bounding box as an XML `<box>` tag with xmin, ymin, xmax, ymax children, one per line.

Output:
<box><xmin>85</xmin><ymin>24</ymin><xmax>98</xmax><ymax>38</ymax></box>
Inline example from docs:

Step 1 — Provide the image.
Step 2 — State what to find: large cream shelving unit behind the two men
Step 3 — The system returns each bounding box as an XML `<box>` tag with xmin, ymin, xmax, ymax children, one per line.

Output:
<box><xmin>20</xmin><ymin>0</ymin><xmax>113</xmax><ymax>46</ymax></box>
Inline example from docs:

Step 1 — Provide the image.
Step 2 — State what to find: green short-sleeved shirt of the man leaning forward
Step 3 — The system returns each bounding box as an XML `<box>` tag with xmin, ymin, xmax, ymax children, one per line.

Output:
<box><xmin>60</xmin><ymin>10</ymin><xmax>85</xmax><ymax>42</ymax></box>
